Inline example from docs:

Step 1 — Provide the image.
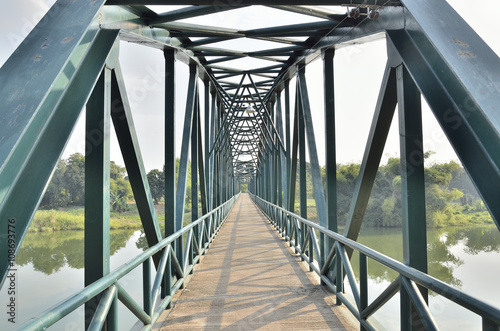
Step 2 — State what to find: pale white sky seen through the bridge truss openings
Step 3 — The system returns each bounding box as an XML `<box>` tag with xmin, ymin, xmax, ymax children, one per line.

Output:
<box><xmin>0</xmin><ymin>0</ymin><xmax>500</xmax><ymax>171</ymax></box>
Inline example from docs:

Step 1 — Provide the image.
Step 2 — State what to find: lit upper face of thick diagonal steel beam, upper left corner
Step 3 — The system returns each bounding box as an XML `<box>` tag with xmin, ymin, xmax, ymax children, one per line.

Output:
<box><xmin>0</xmin><ymin>0</ymin><xmax>105</xmax><ymax>169</ymax></box>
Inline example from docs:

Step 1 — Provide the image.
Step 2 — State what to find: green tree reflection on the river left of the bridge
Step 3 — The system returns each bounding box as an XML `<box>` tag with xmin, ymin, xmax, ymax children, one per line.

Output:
<box><xmin>16</xmin><ymin>230</ymin><xmax>134</xmax><ymax>275</ymax></box>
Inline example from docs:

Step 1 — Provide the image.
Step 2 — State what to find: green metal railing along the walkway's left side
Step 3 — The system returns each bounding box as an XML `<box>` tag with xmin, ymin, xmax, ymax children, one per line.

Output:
<box><xmin>19</xmin><ymin>193</ymin><xmax>239</xmax><ymax>330</ymax></box>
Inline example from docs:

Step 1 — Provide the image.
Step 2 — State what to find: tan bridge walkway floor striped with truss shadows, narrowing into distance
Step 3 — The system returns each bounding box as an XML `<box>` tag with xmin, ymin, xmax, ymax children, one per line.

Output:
<box><xmin>156</xmin><ymin>194</ymin><xmax>358</xmax><ymax>330</ymax></box>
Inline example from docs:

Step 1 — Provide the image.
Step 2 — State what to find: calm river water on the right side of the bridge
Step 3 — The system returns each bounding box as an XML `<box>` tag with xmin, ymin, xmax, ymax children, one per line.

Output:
<box><xmin>353</xmin><ymin>226</ymin><xmax>500</xmax><ymax>330</ymax></box>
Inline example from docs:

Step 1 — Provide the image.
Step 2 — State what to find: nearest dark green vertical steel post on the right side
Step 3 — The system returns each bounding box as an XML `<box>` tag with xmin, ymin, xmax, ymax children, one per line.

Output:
<box><xmin>396</xmin><ymin>65</ymin><xmax>428</xmax><ymax>330</ymax></box>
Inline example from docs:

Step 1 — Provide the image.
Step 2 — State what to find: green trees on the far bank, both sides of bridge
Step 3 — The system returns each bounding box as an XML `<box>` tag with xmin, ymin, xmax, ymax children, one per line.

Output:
<box><xmin>41</xmin><ymin>153</ymin><xmax>493</xmax><ymax>227</ymax></box>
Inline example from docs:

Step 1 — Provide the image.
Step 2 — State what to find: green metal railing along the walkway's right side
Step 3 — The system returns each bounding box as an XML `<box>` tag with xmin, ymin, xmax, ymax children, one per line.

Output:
<box><xmin>250</xmin><ymin>194</ymin><xmax>500</xmax><ymax>330</ymax></box>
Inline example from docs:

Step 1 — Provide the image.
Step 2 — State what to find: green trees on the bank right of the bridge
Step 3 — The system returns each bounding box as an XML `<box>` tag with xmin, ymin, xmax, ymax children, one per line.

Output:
<box><xmin>324</xmin><ymin>154</ymin><xmax>493</xmax><ymax>227</ymax></box>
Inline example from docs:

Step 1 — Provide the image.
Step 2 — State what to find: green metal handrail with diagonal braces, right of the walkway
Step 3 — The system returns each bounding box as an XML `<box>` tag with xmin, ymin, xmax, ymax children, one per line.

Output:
<box><xmin>250</xmin><ymin>193</ymin><xmax>500</xmax><ymax>329</ymax></box>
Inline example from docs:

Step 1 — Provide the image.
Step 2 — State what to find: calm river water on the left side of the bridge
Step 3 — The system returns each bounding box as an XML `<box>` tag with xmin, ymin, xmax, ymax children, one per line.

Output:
<box><xmin>0</xmin><ymin>230</ymin><xmax>146</xmax><ymax>331</ymax></box>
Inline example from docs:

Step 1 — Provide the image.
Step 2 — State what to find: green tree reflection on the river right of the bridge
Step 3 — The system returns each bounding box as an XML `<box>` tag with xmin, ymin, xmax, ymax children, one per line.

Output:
<box><xmin>353</xmin><ymin>226</ymin><xmax>500</xmax><ymax>288</ymax></box>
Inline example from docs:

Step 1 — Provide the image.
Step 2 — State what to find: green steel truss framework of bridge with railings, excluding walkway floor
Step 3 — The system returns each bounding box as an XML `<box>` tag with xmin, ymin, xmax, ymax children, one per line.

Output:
<box><xmin>0</xmin><ymin>0</ymin><xmax>500</xmax><ymax>330</ymax></box>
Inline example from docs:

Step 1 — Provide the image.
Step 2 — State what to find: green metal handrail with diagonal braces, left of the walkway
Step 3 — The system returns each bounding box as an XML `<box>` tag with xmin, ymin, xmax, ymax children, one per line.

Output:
<box><xmin>19</xmin><ymin>193</ymin><xmax>240</xmax><ymax>331</ymax></box>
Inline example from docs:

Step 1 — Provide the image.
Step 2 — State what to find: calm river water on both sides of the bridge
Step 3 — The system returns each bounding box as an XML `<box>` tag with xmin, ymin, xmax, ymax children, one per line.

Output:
<box><xmin>0</xmin><ymin>226</ymin><xmax>500</xmax><ymax>331</ymax></box>
